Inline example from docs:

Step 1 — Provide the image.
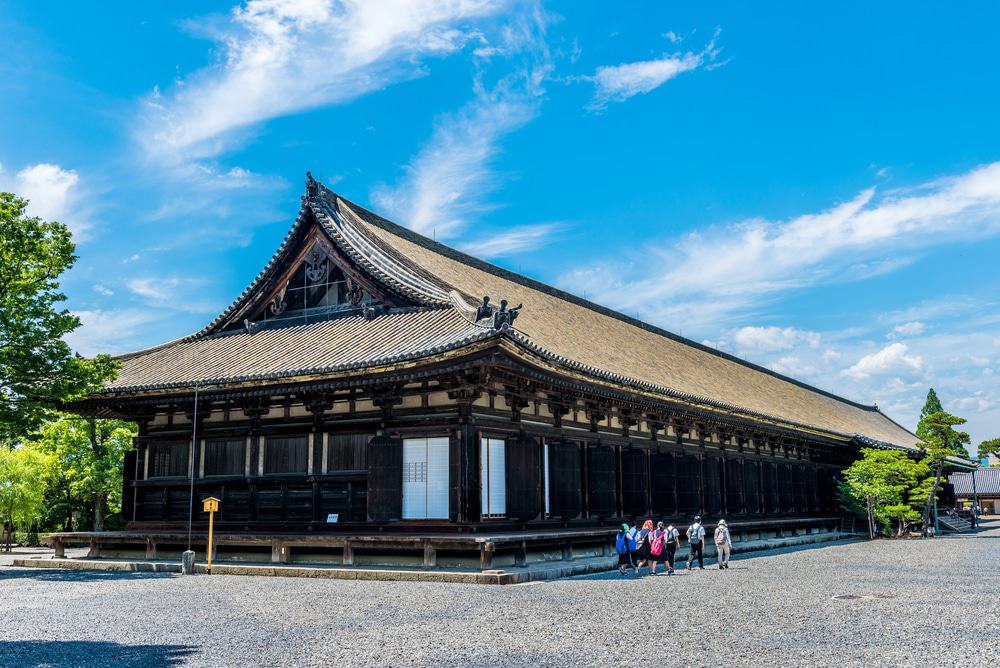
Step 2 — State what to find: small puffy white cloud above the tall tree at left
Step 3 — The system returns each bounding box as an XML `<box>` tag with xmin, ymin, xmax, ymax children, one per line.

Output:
<box><xmin>0</xmin><ymin>162</ymin><xmax>90</xmax><ymax>237</ymax></box>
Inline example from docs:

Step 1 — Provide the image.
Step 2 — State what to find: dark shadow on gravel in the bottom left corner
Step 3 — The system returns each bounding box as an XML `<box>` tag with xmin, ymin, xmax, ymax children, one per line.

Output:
<box><xmin>0</xmin><ymin>640</ymin><xmax>195</xmax><ymax>668</ymax></box>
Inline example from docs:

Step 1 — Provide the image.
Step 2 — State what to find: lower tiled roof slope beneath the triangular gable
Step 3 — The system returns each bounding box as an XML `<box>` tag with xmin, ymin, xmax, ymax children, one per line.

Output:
<box><xmin>106</xmin><ymin>307</ymin><xmax>496</xmax><ymax>393</ymax></box>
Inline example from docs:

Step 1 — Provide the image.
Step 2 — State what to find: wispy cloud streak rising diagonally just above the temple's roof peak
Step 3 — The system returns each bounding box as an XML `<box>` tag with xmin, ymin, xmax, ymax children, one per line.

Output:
<box><xmin>372</xmin><ymin>8</ymin><xmax>551</xmax><ymax>238</ymax></box>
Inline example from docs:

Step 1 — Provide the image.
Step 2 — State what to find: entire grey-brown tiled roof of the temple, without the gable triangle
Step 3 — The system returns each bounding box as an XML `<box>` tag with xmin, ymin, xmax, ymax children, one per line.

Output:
<box><xmin>97</xmin><ymin>176</ymin><xmax>918</xmax><ymax>449</ymax></box>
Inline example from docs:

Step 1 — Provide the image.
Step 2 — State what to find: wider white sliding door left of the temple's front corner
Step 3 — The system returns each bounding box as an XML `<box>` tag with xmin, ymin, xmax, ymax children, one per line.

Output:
<box><xmin>403</xmin><ymin>436</ymin><xmax>448</xmax><ymax>520</ymax></box>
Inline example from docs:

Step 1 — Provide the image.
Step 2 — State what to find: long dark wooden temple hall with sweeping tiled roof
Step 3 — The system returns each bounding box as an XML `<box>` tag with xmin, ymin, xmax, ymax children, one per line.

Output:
<box><xmin>58</xmin><ymin>177</ymin><xmax>964</xmax><ymax>568</ymax></box>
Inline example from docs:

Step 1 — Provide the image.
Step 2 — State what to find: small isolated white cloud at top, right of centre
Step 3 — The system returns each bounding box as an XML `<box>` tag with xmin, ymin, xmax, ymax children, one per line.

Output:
<box><xmin>583</xmin><ymin>33</ymin><xmax>718</xmax><ymax>109</ymax></box>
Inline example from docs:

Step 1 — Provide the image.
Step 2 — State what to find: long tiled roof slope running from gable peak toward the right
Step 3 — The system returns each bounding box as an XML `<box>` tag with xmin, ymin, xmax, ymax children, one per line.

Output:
<box><xmin>334</xmin><ymin>189</ymin><xmax>919</xmax><ymax>447</ymax></box>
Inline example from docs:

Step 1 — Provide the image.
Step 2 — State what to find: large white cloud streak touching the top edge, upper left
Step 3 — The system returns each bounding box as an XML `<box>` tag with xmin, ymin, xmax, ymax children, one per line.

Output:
<box><xmin>138</xmin><ymin>0</ymin><xmax>506</xmax><ymax>159</ymax></box>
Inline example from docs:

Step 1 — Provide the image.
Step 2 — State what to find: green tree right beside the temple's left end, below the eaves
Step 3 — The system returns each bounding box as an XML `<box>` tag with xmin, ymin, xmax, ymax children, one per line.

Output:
<box><xmin>30</xmin><ymin>416</ymin><xmax>138</xmax><ymax>531</ymax></box>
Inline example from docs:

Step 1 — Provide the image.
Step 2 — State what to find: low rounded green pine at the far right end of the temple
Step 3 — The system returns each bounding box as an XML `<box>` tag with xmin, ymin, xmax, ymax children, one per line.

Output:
<box><xmin>842</xmin><ymin>448</ymin><xmax>930</xmax><ymax>538</ymax></box>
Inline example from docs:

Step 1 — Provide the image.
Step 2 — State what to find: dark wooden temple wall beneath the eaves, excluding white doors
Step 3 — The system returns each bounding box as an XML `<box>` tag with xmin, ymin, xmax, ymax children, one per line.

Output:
<box><xmin>123</xmin><ymin>383</ymin><xmax>845</xmax><ymax>530</ymax></box>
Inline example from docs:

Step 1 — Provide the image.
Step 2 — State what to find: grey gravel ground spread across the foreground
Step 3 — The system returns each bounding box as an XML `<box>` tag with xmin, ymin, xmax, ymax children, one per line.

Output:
<box><xmin>0</xmin><ymin>522</ymin><xmax>1000</xmax><ymax>668</ymax></box>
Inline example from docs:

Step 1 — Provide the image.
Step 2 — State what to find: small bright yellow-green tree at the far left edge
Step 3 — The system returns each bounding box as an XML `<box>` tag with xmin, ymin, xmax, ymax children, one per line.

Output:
<box><xmin>0</xmin><ymin>446</ymin><xmax>49</xmax><ymax>552</ymax></box>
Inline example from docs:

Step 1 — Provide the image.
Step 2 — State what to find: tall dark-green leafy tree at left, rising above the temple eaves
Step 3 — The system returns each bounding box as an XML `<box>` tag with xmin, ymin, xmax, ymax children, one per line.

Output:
<box><xmin>0</xmin><ymin>193</ymin><xmax>117</xmax><ymax>443</ymax></box>
